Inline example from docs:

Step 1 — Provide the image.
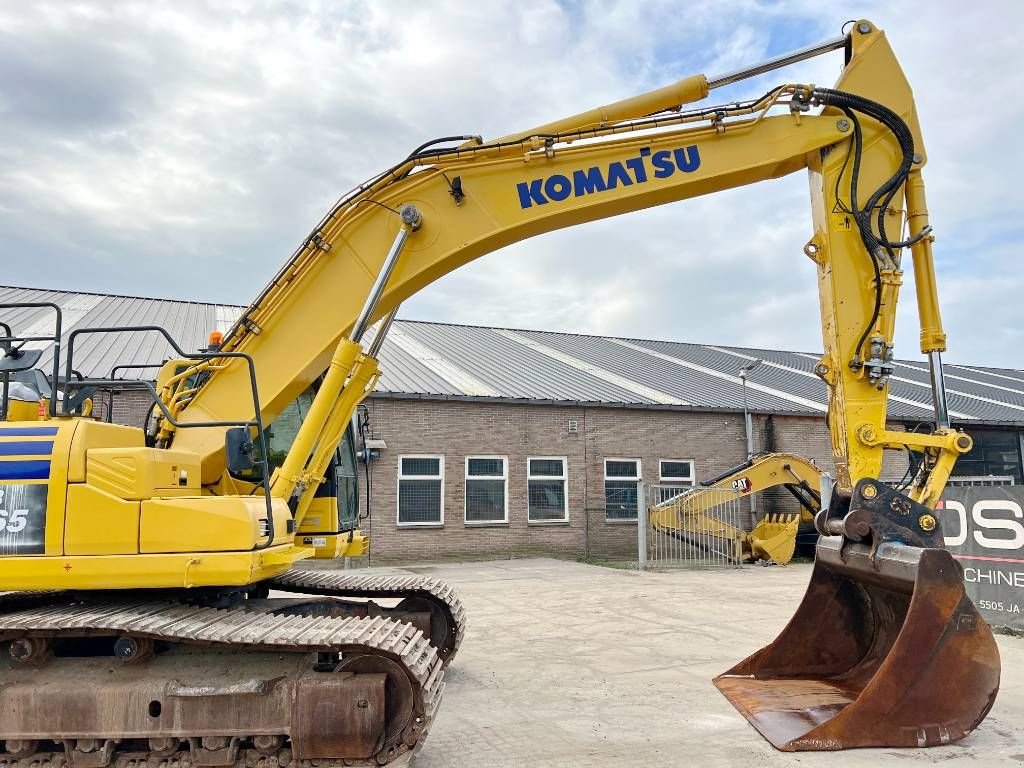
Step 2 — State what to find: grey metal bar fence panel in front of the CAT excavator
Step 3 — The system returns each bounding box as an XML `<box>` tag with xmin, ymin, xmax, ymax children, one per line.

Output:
<box><xmin>637</xmin><ymin>483</ymin><xmax>745</xmax><ymax>569</ymax></box>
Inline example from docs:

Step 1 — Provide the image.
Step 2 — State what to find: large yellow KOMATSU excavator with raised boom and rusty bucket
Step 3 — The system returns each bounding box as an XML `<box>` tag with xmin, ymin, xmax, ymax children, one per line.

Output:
<box><xmin>0</xmin><ymin>20</ymin><xmax>999</xmax><ymax>768</ymax></box>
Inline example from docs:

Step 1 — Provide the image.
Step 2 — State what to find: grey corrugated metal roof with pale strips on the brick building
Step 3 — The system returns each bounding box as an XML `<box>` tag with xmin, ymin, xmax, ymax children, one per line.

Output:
<box><xmin>0</xmin><ymin>287</ymin><xmax>1024</xmax><ymax>425</ymax></box>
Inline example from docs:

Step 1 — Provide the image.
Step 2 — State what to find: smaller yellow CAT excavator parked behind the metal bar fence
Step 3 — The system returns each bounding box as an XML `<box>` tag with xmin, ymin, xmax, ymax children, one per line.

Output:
<box><xmin>647</xmin><ymin>454</ymin><xmax>822</xmax><ymax>565</ymax></box>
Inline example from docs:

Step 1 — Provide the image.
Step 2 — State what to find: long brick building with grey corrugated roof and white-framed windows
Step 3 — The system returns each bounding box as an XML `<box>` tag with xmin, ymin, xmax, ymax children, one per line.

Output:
<box><xmin>0</xmin><ymin>289</ymin><xmax>1024</xmax><ymax>563</ymax></box>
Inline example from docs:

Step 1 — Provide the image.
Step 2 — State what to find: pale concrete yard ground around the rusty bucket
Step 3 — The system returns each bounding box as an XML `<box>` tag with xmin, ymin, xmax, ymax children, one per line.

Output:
<box><xmin>366</xmin><ymin>559</ymin><xmax>1024</xmax><ymax>768</ymax></box>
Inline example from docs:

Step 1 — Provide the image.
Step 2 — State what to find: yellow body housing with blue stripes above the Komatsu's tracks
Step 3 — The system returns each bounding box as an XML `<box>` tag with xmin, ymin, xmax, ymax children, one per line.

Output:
<box><xmin>0</xmin><ymin>419</ymin><xmax>308</xmax><ymax>590</ymax></box>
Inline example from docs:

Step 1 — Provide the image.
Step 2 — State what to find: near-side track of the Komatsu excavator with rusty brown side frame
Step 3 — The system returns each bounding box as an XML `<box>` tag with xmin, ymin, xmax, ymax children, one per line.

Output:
<box><xmin>0</xmin><ymin>593</ymin><xmax>443</xmax><ymax>768</ymax></box>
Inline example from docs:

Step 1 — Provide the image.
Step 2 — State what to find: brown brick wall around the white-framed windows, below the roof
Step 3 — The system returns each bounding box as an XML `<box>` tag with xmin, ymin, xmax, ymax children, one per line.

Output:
<box><xmin>368</xmin><ymin>397</ymin><xmax>829</xmax><ymax>564</ymax></box>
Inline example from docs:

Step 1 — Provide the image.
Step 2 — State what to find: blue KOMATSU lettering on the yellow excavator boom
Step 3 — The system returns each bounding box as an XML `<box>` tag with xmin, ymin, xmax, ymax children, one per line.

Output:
<box><xmin>516</xmin><ymin>144</ymin><xmax>700</xmax><ymax>209</ymax></box>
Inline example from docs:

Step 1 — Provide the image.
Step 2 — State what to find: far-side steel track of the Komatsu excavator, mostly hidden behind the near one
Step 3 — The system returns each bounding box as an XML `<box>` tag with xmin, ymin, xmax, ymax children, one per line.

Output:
<box><xmin>265</xmin><ymin>568</ymin><xmax>466</xmax><ymax>667</ymax></box>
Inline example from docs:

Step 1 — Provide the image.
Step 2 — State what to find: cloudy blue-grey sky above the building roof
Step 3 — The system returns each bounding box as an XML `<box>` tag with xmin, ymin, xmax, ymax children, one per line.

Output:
<box><xmin>0</xmin><ymin>0</ymin><xmax>1024</xmax><ymax>368</ymax></box>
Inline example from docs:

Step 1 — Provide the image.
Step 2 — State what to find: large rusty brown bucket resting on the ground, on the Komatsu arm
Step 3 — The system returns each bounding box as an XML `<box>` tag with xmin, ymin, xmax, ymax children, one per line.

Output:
<box><xmin>715</xmin><ymin>536</ymin><xmax>999</xmax><ymax>752</ymax></box>
